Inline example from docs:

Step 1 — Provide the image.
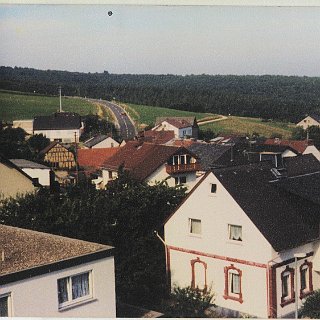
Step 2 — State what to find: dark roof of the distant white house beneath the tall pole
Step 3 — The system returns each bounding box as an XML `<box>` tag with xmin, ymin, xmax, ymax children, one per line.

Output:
<box><xmin>33</xmin><ymin>112</ymin><xmax>81</xmax><ymax>131</ymax></box>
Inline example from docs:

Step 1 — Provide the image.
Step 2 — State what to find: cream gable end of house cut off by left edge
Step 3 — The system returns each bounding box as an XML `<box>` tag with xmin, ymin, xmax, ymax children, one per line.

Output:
<box><xmin>0</xmin><ymin>154</ymin><xmax>40</xmax><ymax>198</ymax></box>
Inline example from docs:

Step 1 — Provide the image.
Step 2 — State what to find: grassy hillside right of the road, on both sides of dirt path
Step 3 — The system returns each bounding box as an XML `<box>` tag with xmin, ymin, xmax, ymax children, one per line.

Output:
<box><xmin>122</xmin><ymin>104</ymin><xmax>293</xmax><ymax>138</ymax></box>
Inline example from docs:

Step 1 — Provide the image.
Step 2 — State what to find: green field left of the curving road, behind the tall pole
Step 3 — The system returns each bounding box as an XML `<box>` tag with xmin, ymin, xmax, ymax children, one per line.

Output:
<box><xmin>0</xmin><ymin>91</ymin><xmax>97</xmax><ymax>121</ymax></box>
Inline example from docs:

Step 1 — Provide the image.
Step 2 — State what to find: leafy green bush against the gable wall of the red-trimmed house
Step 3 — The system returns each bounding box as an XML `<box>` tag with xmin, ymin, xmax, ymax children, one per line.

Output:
<box><xmin>165</xmin><ymin>286</ymin><xmax>214</xmax><ymax>318</ymax></box>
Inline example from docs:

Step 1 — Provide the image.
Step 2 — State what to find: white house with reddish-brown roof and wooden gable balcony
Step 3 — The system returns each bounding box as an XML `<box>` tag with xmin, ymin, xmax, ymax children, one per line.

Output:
<box><xmin>102</xmin><ymin>141</ymin><xmax>200</xmax><ymax>190</ymax></box>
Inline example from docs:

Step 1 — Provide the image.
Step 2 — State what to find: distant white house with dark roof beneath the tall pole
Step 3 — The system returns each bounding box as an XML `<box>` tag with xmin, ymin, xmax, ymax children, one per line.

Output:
<box><xmin>33</xmin><ymin>112</ymin><xmax>84</xmax><ymax>143</ymax></box>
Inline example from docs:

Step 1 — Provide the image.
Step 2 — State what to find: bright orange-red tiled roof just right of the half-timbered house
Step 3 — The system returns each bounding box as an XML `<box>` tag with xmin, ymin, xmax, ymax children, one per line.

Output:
<box><xmin>78</xmin><ymin>148</ymin><xmax>120</xmax><ymax>169</ymax></box>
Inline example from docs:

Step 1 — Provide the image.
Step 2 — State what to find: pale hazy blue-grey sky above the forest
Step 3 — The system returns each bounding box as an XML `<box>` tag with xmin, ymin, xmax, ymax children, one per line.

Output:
<box><xmin>0</xmin><ymin>4</ymin><xmax>320</xmax><ymax>76</ymax></box>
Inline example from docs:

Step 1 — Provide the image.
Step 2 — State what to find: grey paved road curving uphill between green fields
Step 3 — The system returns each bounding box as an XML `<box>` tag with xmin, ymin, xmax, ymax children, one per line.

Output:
<box><xmin>88</xmin><ymin>99</ymin><xmax>136</xmax><ymax>140</ymax></box>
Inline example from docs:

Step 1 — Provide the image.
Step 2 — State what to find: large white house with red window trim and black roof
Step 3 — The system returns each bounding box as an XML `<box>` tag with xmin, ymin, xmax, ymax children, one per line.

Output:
<box><xmin>165</xmin><ymin>163</ymin><xmax>320</xmax><ymax>318</ymax></box>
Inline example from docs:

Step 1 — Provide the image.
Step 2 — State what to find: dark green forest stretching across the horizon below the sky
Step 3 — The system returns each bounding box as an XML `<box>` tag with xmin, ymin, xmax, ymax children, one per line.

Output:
<box><xmin>0</xmin><ymin>67</ymin><xmax>320</xmax><ymax>122</ymax></box>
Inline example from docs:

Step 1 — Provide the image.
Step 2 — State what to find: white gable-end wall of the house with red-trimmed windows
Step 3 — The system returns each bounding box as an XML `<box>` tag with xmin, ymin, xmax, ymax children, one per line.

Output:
<box><xmin>165</xmin><ymin>173</ymin><xmax>274</xmax><ymax>317</ymax></box>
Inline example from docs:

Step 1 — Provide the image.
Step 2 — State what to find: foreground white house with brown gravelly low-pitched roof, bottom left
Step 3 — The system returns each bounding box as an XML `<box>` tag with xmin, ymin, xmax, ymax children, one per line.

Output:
<box><xmin>0</xmin><ymin>225</ymin><xmax>116</xmax><ymax>318</ymax></box>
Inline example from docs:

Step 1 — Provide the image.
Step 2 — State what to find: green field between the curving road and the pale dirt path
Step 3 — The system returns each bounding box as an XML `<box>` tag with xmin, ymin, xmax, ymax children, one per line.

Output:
<box><xmin>121</xmin><ymin>104</ymin><xmax>218</xmax><ymax>126</ymax></box>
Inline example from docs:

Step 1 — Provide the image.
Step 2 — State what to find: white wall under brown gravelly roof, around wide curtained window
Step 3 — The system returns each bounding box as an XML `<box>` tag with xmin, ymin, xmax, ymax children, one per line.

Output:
<box><xmin>1</xmin><ymin>257</ymin><xmax>116</xmax><ymax>318</ymax></box>
